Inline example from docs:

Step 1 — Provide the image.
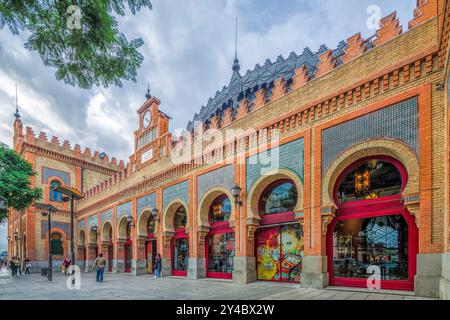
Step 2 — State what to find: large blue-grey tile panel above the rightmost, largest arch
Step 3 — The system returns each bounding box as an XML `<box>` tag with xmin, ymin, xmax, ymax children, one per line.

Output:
<box><xmin>322</xmin><ymin>98</ymin><xmax>418</xmax><ymax>175</ymax></box>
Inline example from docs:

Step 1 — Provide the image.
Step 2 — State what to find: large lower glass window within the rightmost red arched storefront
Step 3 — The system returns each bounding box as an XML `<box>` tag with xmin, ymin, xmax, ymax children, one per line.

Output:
<box><xmin>333</xmin><ymin>215</ymin><xmax>408</xmax><ymax>280</ymax></box>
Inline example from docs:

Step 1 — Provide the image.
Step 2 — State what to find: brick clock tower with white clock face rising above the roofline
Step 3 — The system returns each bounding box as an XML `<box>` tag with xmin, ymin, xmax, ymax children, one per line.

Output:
<box><xmin>130</xmin><ymin>89</ymin><xmax>172</xmax><ymax>171</ymax></box>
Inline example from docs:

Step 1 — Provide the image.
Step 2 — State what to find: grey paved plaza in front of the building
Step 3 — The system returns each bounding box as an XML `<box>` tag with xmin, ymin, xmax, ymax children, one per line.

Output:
<box><xmin>0</xmin><ymin>270</ymin><xmax>432</xmax><ymax>300</ymax></box>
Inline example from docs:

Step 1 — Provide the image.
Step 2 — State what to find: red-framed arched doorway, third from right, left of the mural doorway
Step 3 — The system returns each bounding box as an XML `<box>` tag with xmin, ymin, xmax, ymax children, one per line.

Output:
<box><xmin>206</xmin><ymin>194</ymin><xmax>235</xmax><ymax>279</ymax></box>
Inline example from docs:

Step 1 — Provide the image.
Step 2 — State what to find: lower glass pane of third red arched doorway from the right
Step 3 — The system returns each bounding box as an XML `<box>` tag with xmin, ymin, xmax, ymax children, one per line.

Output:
<box><xmin>208</xmin><ymin>232</ymin><xmax>234</xmax><ymax>273</ymax></box>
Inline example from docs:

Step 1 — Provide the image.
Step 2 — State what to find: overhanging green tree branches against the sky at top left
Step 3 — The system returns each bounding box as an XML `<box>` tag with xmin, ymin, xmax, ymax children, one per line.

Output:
<box><xmin>0</xmin><ymin>0</ymin><xmax>152</xmax><ymax>88</ymax></box>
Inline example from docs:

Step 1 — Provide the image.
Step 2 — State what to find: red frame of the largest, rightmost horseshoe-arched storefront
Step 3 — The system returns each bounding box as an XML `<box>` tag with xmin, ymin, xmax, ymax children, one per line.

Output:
<box><xmin>326</xmin><ymin>156</ymin><xmax>418</xmax><ymax>291</ymax></box>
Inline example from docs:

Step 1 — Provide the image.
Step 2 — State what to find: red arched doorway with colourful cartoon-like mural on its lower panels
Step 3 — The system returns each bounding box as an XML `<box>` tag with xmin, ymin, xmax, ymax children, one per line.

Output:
<box><xmin>255</xmin><ymin>179</ymin><xmax>303</xmax><ymax>282</ymax></box>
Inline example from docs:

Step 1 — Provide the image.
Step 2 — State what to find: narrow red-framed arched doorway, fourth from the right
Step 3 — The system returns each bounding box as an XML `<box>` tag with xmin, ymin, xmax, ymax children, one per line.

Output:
<box><xmin>171</xmin><ymin>205</ymin><xmax>189</xmax><ymax>277</ymax></box>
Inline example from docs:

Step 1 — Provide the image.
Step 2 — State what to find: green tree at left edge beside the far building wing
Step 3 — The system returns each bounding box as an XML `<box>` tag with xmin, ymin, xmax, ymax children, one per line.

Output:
<box><xmin>0</xmin><ymin>143</ymin><xmax>42</xmax><ymax>223</ymax></box>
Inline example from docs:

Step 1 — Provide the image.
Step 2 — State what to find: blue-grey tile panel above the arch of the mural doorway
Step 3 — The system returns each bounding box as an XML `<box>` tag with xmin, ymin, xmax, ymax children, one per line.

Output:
<box><xmin>246</xmin><ymin>138</ymin><xmax>304</xmax><ymax>193</ymax></box>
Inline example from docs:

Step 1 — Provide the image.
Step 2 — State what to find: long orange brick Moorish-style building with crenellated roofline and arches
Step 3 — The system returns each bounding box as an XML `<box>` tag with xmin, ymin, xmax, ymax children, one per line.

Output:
<box><xmin>8</xmin><ymin>0</ymin><xmax>450</xmax><ymax>298</ymax></box>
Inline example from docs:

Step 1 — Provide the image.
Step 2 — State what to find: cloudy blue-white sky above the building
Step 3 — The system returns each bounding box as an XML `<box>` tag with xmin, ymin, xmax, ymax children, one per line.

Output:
<box><xmin>0</xmin><ymin>0</ymin><xmax>416</xmax><ymax>249</ymax></box>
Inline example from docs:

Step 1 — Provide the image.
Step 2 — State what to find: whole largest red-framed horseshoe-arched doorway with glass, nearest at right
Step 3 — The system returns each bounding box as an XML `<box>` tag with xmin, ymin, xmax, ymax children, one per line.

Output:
<box><xmin>327</xmin><ymin>156</ymin><xmax>417</xmax><ymax>290</ymax></box>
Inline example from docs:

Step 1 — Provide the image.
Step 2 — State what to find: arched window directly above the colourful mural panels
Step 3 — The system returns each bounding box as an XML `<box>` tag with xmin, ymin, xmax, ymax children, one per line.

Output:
<box><xmin>259</xmin><ymin>180</ymin><xmax>298</xmax><ymax>215</ymax></box>
